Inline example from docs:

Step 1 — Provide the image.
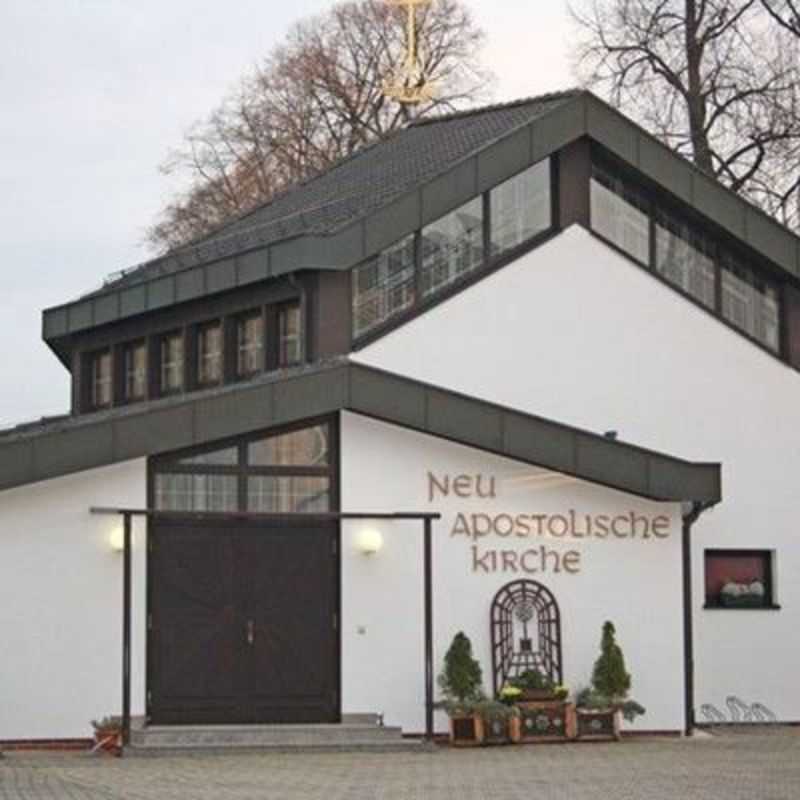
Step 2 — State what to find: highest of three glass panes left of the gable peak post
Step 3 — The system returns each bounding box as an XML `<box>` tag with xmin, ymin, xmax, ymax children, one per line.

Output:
<box><xmin>490</xmin><ymin>159</ymin><xmax>551</xmax><ymax>254</ymax></box>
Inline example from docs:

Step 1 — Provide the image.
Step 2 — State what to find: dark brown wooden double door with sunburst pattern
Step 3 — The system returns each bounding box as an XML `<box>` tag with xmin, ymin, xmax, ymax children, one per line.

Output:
<box><xmin>147</xmin><ymin>521</ymin><xmax>339</xmax><ymax>724</ymax></box>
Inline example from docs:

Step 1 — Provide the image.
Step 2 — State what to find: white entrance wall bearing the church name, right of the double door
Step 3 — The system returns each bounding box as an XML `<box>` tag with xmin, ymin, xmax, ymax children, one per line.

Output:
<box><xmin>341</xmin><ymin>413</ymin><xmax>683</xmax><ymax>732</ymax></box>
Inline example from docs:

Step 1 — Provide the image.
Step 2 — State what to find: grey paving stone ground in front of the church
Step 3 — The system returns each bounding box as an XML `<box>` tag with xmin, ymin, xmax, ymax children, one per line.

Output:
<box><xmin>0</xmin><ymin>728</ymin><xmax>800</xmax><ymax>800</ymax></box>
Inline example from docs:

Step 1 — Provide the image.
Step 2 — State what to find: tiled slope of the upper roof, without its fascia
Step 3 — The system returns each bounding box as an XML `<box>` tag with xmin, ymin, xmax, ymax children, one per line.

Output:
<box><xmin>94</xmin><ymin>90</ymin><xmax>577</xmax><ymax>291</ymax></box>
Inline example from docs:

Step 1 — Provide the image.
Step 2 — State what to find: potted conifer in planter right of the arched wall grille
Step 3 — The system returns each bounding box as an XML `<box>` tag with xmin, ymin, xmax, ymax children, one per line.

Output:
<box><xmin>576</xmin><ymin>622</ymin><xmax>645</xmax><ymax>740</ymax></box>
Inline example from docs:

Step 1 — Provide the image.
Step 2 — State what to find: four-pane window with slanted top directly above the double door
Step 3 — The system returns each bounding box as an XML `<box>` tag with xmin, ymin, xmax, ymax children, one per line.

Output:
<box><xmin>153</xmin><ymin>422</ymin><xmax>337</xmax><ymax>514</ymax></box>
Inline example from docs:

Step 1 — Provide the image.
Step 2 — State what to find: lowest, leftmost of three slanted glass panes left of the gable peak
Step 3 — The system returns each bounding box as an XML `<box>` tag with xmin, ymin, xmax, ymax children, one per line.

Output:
<box><xmin>353</xmin><ymin>234</ymin><xmax>414</xmax><ymax>336</ymax></box>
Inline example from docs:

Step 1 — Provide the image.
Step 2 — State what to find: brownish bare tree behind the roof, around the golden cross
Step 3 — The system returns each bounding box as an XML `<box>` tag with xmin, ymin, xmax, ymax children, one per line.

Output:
<box><xmin>148</xmin><ymin>0</ymin><xmax>490</xmax><ymax>250</ymax></box>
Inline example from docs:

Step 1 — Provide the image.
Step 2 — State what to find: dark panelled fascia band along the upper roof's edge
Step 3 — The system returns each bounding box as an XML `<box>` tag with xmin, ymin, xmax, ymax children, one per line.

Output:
<box><xmin>43</xmin><ymin>92</ymin><xmax>800</xmax><ymax>342</ymax></box>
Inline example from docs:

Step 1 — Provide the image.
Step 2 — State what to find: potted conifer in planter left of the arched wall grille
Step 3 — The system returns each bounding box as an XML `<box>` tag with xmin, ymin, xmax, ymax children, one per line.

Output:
<box><xmin>439</xmin><ymin>632</ymin><xmax>485</xmax><ymax>747</ymax></box>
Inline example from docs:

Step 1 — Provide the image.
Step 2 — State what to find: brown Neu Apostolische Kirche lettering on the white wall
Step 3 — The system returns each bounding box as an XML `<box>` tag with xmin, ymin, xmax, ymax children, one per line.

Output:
<box><xmin>428</xmin><ymin>472</ymin><xmax>671</xmax><ymax>575</ymax></box>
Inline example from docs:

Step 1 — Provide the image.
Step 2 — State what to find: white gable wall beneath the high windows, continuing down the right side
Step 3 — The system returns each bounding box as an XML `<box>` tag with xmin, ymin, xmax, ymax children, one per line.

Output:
<box><xmin>355</xmin><ymin>226</ymin><xmax>800</xmax><ymax>721</ymax></box>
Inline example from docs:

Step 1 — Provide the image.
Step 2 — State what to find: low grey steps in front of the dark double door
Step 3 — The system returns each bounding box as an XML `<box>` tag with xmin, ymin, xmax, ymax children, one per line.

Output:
<box><xmin>125</xmin><ymin>722</ymin><xmax>422</xmax><ymax>755</ymax></box>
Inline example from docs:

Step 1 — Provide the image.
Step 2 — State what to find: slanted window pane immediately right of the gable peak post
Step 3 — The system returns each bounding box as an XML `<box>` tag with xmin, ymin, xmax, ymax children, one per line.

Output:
<box><xmin>590</xmin><ymin>164</ymin><xmax>650</xmax><ymax>264</ymax></box>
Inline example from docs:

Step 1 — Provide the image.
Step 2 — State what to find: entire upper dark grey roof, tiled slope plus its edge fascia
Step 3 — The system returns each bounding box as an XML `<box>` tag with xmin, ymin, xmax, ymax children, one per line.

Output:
<box><xmin>43</xmin><ymin>91</ymin><xmax>800</xmax><ymax>342</ymax></box>
